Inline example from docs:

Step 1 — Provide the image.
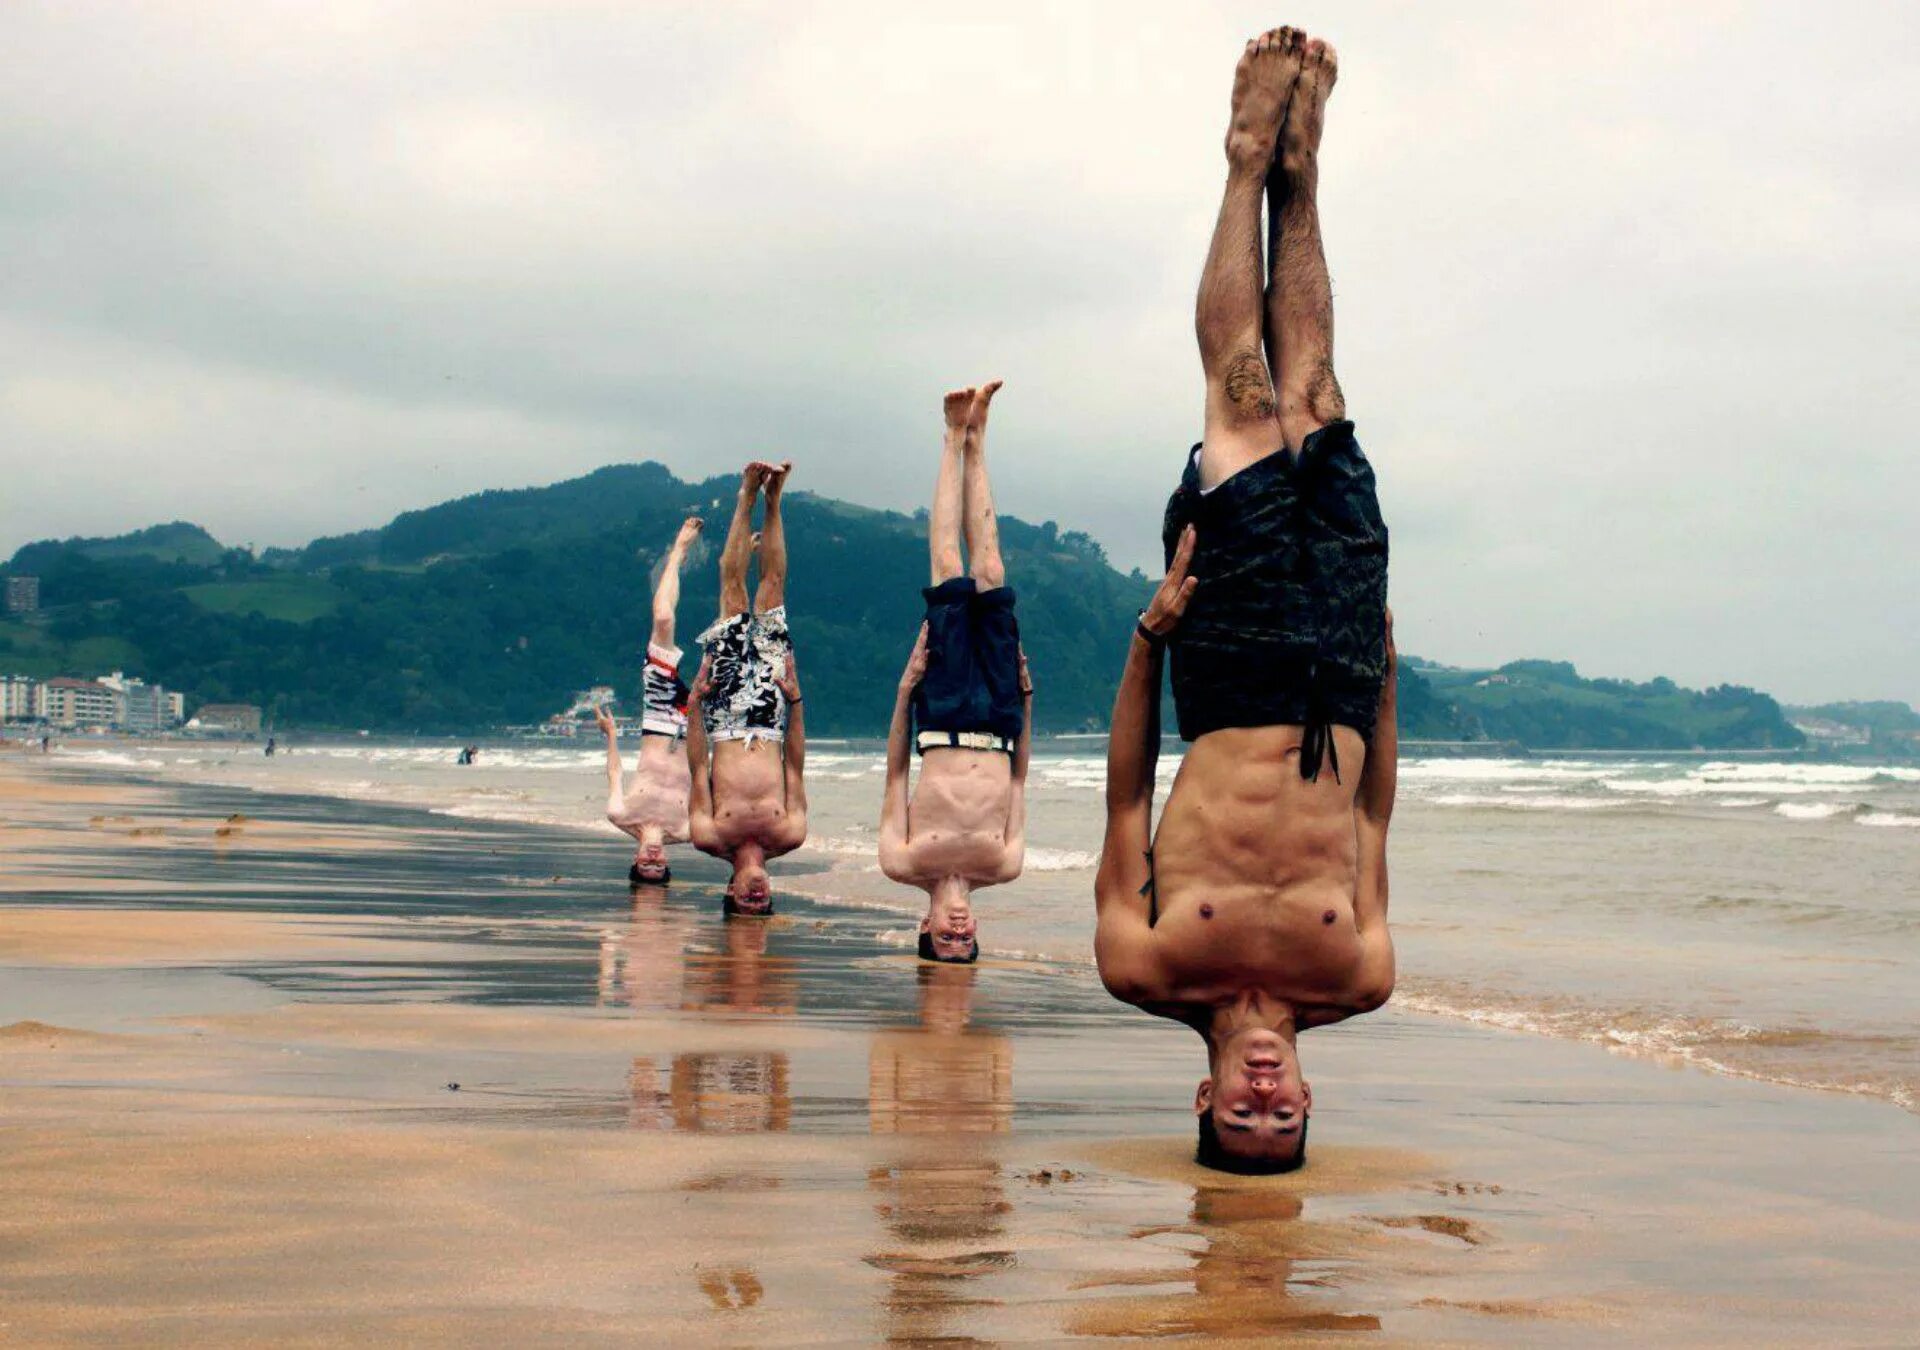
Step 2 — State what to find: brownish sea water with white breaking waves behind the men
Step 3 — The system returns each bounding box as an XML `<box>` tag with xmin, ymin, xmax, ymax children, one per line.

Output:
<box><xmin>45</xmin><ymin>741</ymin><xmax>1920</xmax><ymax>1110</ymax></box>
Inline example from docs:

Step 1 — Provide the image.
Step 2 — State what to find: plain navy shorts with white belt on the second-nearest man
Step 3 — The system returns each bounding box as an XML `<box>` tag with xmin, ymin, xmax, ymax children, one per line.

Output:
<box><xmin>914</xmin><ymin>576</ymin><xmax>1025</xmax><ymax>741</ymax></box>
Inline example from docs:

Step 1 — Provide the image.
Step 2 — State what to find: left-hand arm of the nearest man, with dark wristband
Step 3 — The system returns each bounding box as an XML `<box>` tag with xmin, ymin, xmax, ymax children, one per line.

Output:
<box><xmin>1094</xmin><ymin>528</ymin><xmax>1196</xmax><ymax>999</ymax></box>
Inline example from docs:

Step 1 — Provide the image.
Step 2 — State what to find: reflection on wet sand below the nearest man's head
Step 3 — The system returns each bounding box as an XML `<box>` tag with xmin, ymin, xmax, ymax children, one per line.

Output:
<box><xmin>1069</xmin><ymin>1181</ymin><xmax>1380</xmax><ymax>1338</ymax></box>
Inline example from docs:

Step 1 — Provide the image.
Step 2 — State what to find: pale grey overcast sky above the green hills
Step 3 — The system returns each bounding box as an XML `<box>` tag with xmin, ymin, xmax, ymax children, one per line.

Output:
<box><xmin>0</xmin><ymin>0</ymin><xmax>1920</xmax><ymax>701</ymax></box>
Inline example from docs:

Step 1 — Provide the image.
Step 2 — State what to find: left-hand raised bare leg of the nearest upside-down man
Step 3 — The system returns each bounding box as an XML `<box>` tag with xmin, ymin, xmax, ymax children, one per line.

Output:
<box><xmin>1194</xmin><ymin>29</ymin><xmax>1298</xmax><ymax>486</ymax></box>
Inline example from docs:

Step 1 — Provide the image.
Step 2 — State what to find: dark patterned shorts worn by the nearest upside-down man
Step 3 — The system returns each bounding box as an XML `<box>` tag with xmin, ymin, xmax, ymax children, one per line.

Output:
<box><xmin>1162</xmin><ymin>421</ymin><xmax>1386</xmax><ymax>741</ymax></box>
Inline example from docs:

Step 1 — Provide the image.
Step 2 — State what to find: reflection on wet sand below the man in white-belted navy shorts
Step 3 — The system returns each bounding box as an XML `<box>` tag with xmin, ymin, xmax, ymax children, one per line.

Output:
<box><xmin>866</xmin><ymin>966</ymin><xmax>1014</xmax><ymax>1342</ymax></box>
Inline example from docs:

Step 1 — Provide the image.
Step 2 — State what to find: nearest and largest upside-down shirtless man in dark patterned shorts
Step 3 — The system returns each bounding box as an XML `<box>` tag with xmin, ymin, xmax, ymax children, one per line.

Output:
<box><xmin>1094</xmin><ymin>29</ymin><xmax>1398</xmax><ymax>1171</ymax></box>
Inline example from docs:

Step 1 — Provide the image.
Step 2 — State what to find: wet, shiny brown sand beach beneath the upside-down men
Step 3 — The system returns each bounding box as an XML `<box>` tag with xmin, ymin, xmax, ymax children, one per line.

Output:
<box><xmin>0</xmin><ymin>759</ymin><xmax>1920</xmax><ymax>1344</ymax></box>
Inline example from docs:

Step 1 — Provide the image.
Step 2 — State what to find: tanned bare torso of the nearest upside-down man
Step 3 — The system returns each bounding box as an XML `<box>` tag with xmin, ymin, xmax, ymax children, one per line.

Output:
<box><xmin>1133</xmin><ymin>726</ymin><xmax>1386</xmax><ymax>1022</ymax></box>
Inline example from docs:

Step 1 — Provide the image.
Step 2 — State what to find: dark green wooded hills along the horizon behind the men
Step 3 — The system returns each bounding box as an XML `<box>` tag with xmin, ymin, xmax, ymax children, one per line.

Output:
<box><xmin>0</xmin><ymin>463</ymin><xmax>1827</xmax><ymax>749</ymax></box>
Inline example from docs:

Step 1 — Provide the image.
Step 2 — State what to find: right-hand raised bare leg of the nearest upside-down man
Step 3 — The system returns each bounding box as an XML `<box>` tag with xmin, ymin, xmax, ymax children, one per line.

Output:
<box><xmin>1267</xmin><ymin>38</ymin><xmax>1346</xmax><ymax>453</ymax></box>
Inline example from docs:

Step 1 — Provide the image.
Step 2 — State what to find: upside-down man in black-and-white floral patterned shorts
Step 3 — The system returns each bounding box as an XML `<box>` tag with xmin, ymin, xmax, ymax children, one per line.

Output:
<box><xmin>687</xmin><ymin>461</ymin><xmax>806</xmax><ymax>914</ymax></box>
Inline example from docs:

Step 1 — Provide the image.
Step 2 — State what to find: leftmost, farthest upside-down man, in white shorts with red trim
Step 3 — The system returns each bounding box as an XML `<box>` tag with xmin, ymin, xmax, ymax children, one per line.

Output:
<box><xmin>593</xmin><ymin>517</ymin><xmax>705</xmax><ymax>885</ymax></box>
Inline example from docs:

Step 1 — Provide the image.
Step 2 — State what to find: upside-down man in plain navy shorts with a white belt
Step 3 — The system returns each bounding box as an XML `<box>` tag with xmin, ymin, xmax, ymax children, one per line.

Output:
<box><xmin>879</xmin><ymin>380</ymin><xmax>1033</xmax><ymax>962</ymax></box>
